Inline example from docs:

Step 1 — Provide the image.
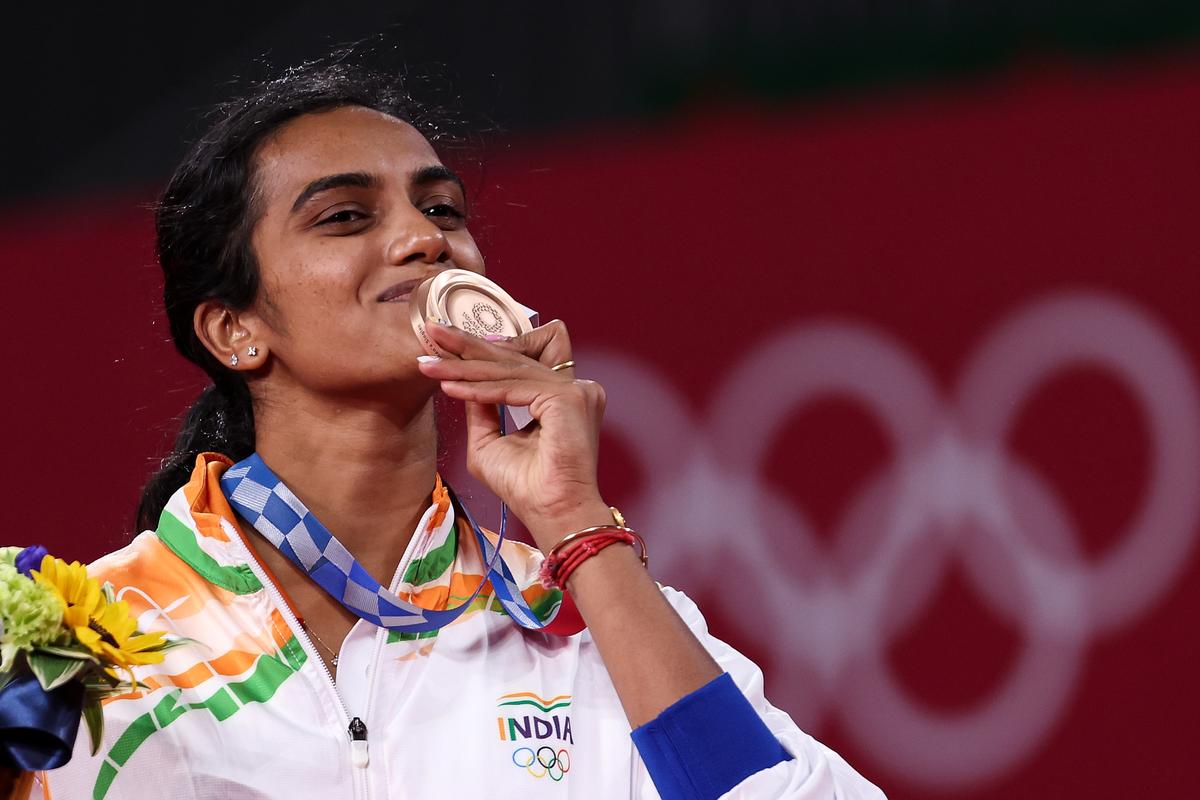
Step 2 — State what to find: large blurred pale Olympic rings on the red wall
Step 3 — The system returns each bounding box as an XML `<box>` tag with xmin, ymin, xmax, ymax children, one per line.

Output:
<box><xmin>577</xmin><ymin>293</ymin><xmax>1200</xmax><ymax>789</ymax></box>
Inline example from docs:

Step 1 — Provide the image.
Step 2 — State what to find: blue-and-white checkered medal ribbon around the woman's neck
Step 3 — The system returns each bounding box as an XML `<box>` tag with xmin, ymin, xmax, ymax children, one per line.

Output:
<box><xmin>221</xmin><ymin>452</ymin><xmax>552</xmax><ymax>633</ymax></box>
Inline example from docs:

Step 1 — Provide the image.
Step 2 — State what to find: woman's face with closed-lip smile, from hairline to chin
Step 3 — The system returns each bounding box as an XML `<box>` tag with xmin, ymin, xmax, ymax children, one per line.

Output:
<box><xmin>247</xmin><ymin>107</ymin><xmax>484</xmax><ymax>395</ymax></box>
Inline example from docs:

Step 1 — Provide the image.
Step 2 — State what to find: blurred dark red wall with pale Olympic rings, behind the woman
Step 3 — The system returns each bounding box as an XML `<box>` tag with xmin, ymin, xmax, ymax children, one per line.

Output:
<box><xmin>0</xmin><ymin>53</ymin><xmax>1200</xmax><ymax>800</ymax></box>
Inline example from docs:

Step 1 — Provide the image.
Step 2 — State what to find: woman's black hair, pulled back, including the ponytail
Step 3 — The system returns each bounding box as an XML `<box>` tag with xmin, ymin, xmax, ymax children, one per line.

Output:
<box><xmin>137</xmin><ymin>61</ymin><xmax>457</xmax><ymax>530</ymax></box>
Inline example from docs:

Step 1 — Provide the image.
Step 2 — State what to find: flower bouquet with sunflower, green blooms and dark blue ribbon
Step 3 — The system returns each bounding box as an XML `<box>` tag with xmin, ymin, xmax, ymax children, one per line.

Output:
<box><xmin>0</xmin><ymin>546</ymin><xmax>187</xmax><ymax>798</ymax></box>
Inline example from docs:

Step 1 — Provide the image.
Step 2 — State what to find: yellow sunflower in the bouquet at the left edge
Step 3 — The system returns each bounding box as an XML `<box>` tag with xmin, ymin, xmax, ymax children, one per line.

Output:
<box><xmin>32</xmin><ymin>555</ymin><xmax>166</xmax><ymax>680</ymax></box>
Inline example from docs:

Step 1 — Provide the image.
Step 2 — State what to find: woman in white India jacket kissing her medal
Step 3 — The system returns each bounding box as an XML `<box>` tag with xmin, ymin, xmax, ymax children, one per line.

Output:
<box><xmin>39</xmin><ymin>66</ymin><xmax>882</xmax><ymax>800</ymax></box>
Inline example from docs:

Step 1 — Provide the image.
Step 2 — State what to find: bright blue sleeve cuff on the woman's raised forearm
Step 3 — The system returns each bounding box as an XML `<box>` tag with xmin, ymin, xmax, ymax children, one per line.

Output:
<box><xmin>632</xmin><ymin>673</ymin><xmax>792</xmax><ymax>800</ymax></box>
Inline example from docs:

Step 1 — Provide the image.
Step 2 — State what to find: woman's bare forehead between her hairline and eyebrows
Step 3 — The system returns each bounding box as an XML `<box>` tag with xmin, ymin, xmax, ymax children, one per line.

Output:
<box><xmin>256</xmin><ymin>106</ymin><xmax>440</xmax><ymax>203</ymax></box>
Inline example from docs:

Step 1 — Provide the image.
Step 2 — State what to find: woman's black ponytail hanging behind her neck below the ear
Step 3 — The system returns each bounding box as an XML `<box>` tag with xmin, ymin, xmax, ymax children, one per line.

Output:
<box><xmin>138</xmin><ymin>378</ymin><xmax>254</xmax><ymax>530</ymax></box>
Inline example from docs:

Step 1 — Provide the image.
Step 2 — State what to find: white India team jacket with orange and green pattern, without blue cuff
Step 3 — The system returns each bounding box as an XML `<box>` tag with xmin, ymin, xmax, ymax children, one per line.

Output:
<box><xmin>35</xmin><ymin>455</ymin><xmax>883</xmax><ymax>800</ymax></box>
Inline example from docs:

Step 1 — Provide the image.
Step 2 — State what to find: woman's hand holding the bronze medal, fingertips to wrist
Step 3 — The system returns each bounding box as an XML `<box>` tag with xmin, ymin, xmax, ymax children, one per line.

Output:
<box><xmin>419</xmin><ymin>320</ymin><xmax>612</xmax><ymax>551</ymax></box>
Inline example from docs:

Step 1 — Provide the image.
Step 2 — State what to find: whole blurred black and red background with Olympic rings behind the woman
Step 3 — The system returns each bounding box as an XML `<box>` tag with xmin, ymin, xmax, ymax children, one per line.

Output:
<box><xmin>0</xmin><ymin>0</ymin><xmax>1200</xmax><ymax>800</ymax></box>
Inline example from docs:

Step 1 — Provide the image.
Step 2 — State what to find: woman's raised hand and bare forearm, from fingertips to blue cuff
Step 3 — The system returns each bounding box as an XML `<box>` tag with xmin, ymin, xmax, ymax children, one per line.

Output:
<box><xmin>419</xmin><ymin>321</ymin><xmax>721</xmax><ymax>727</ymax></box>
